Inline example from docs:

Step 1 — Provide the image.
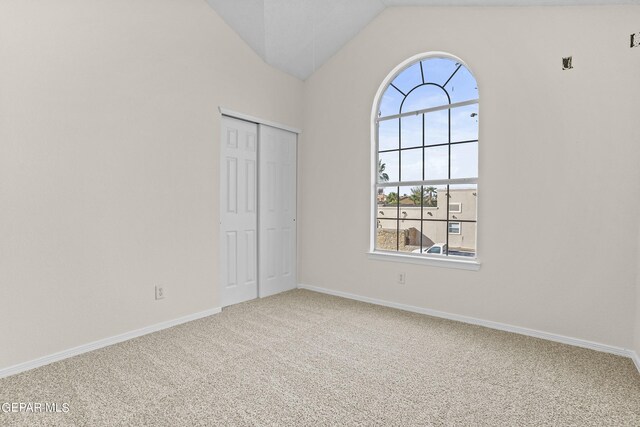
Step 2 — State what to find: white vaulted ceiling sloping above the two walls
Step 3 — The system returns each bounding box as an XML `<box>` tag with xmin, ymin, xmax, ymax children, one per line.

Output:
<box><xmin>207</xmin><ymin>0</ymin><xmax>640</xmax><ymax>80</ymax></box>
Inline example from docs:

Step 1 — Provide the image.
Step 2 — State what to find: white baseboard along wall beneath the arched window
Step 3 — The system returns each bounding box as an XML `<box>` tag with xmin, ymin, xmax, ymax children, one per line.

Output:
<box><xmin>298</xmin><ymin>284</ymin><xmax>640</xmax><ymax>372</ymax></box>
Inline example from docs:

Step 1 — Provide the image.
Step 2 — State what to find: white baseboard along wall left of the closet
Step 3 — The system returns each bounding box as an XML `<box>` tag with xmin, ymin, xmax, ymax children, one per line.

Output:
<box><xmin>0</xmin><ymin>307</ymin><xmax>222</xmax><ymax>378</ymax></box>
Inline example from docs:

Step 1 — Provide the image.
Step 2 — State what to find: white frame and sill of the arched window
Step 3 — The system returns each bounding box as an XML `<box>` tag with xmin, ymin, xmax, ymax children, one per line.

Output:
<box><xmin>368</xmin><ymin>52</ymin><xmax>480</xmax><ymax>270</ymax></box>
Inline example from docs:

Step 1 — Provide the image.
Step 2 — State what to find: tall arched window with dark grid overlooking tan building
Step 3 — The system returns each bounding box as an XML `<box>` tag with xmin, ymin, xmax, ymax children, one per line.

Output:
<box><xmin>372</xmin><ymin>54</ymin><xmax>479</xmax><ymax>261</ymax></box>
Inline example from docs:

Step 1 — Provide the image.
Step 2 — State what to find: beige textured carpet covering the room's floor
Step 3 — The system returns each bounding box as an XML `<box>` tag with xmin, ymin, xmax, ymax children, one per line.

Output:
<box><xmin>0</xmin><ymin>290</ymin><xmax>640</xmax><ymax>426</ymax></box>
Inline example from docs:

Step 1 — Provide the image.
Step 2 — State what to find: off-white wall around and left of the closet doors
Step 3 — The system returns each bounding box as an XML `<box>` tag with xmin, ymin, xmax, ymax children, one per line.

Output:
<box><xmin>0</xmin><ymin>0</ymin><xmax>302</xmax><ymax>368</ymax></box>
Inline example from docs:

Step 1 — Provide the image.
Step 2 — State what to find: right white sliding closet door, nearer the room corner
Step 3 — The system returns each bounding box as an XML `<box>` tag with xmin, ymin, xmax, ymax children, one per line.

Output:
<box><xmin>258</xmin><ymin>125</ymin><xmax>297</xmax><ymax>297</ymax></box>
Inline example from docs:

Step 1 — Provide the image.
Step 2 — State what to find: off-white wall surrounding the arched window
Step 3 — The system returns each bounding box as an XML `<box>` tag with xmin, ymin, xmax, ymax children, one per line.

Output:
<box><xmin>299</xmin><ymin>6</ymin><xmax>640</xmax><ymax>348</ymax></box>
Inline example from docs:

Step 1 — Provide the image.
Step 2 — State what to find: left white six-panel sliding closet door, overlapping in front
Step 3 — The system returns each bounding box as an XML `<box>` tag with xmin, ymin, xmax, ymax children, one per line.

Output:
<box><xmin>220</xmin><ymin>116</ymin><xmax>258</xmax><ymax>307</ymax></box>
